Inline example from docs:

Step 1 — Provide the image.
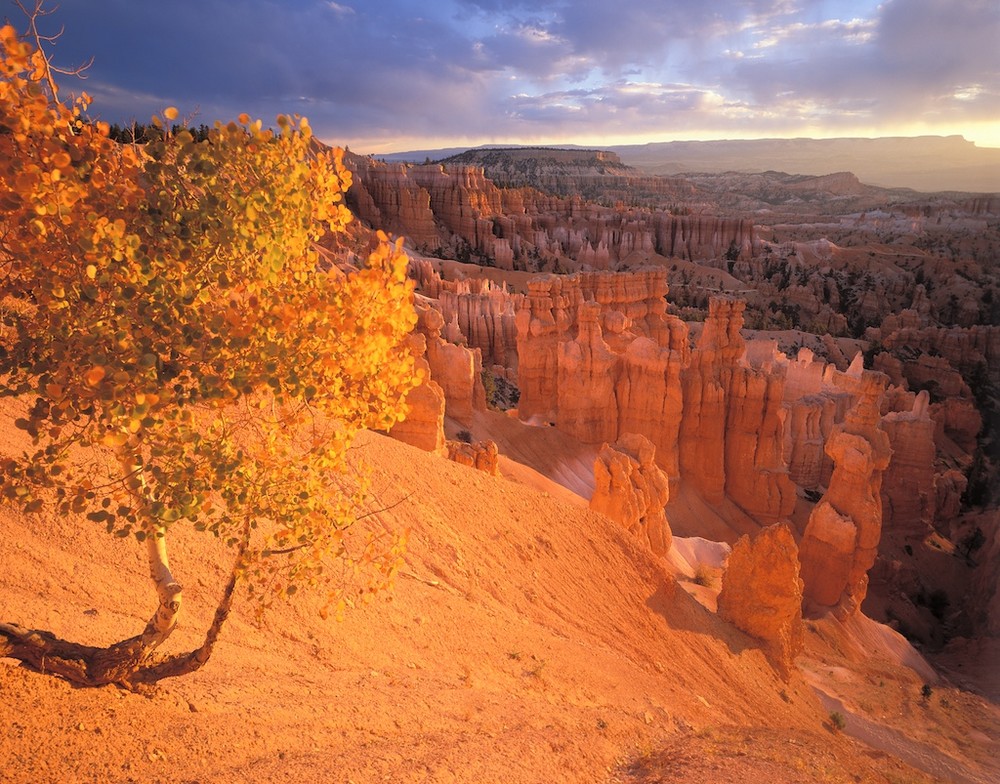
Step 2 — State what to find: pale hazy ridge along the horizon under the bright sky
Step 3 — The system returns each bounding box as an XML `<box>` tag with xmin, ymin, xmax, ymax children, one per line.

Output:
<box><xmin>375</xmin><ymin>136</ymin><xmax>1000</xmax><ymax>193</ymax></box>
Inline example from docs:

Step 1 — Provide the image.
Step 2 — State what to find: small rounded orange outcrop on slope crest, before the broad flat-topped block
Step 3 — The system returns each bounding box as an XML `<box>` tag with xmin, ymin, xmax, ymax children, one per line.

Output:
<box><xmin>590</xmin><ymin>433</ymin><xmax>672</xmax><ymax>556</ymax></box>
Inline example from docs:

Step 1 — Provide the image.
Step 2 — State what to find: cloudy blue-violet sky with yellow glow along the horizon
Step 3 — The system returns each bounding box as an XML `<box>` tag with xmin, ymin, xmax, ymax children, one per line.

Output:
<box><xmin>7</xmin><ymin>0</ymin><xmax>1000</xmax><ymax>154</ymax></box>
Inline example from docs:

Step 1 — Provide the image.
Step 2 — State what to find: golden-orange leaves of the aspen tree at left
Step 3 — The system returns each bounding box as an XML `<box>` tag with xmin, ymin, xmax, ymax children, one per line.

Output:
<box><xmin>0</xmin><ymin>26</ymin><xmax>416</xmax><ymax>609</ymax></box>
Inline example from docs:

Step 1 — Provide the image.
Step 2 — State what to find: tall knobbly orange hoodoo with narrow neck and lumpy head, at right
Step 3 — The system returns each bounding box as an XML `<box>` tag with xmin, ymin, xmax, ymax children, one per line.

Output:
<box><xmin>799</xmin><ymin>362</ymin><xmax>892</xmax><ymax>618</ymax></box>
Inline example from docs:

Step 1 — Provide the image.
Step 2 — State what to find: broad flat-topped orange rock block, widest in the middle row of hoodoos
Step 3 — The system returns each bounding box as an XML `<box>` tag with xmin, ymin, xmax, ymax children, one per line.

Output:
<box><xmin>517</xmin><ymin>270</ymin><xmax>689</xmax><ymax>478</ymax></box>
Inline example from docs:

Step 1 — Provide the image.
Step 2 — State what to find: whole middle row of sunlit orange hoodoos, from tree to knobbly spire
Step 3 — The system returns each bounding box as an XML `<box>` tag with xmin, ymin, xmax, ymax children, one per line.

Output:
<box><xmin>398</xmin><ymin>258</ymin><xmax>944</xmax><ymax>617</ymax></box>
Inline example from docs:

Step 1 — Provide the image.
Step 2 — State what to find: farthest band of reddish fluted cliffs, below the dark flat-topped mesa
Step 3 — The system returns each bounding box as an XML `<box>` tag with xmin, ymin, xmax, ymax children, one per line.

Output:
<box><xmin>347</xmin><ymin>156</ymin><xmax>759</xmax><ymax>271</ymax></box>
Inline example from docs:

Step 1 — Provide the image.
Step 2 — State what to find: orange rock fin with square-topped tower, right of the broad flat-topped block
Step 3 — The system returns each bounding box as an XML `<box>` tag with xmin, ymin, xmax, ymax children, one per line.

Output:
<box><xmin>678</xmin><ymin>297</ymin><xmax>795</xmax><ymax>523</ymax></box>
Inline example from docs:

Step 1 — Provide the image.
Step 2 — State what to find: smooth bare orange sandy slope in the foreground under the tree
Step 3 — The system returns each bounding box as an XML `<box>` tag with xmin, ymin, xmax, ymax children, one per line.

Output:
<box><xmin>0</xmin><ymin>426</ymin><xmax>1000</xmax><ymax>784</ymax></box>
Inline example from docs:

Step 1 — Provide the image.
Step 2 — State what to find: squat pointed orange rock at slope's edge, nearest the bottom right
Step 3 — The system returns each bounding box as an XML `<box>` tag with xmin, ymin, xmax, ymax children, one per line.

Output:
<box><xmin>718</xmin><ymin>523</ymin><xmax>803</xmax><ymax>679</ymax></box>
